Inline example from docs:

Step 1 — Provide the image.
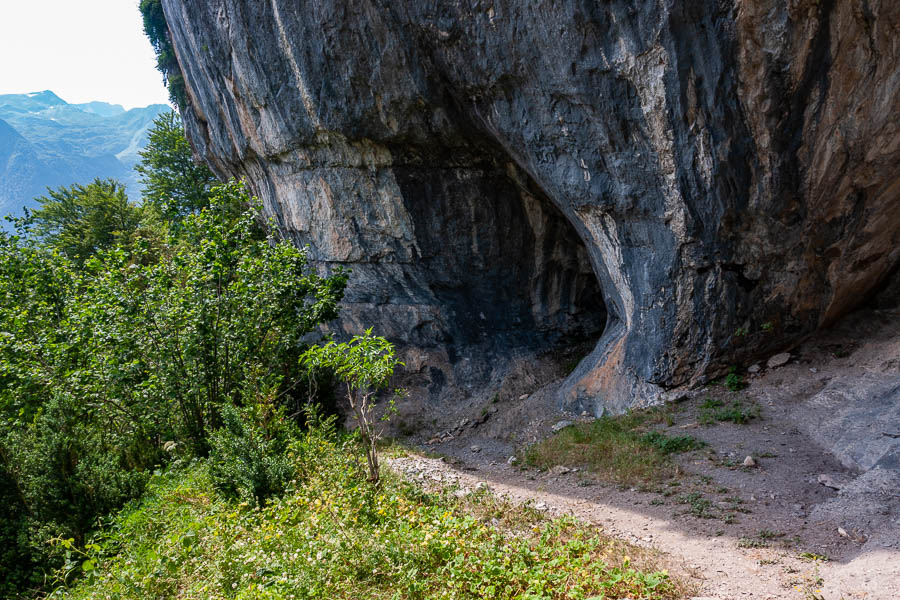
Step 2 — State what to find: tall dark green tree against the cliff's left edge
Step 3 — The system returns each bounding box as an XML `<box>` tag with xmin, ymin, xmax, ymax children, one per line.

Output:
<box><xmin>135</xmin><ymin>111</ymin><xmax>217</xmax><ymax>223</ymax></box>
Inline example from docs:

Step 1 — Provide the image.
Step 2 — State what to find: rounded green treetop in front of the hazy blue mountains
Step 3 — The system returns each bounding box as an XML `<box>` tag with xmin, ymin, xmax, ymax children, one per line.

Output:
<box><xmin>25</xmin><ymin>178</ymin><xmax>142</xmax><ymax>262</ymax></box>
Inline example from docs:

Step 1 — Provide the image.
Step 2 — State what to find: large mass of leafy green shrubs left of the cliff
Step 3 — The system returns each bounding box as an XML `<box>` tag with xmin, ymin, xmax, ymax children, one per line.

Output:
<box><xmin>0</xmin><ymin>183</ymin><xmax>346</xmax><ymax>580</ymax></box>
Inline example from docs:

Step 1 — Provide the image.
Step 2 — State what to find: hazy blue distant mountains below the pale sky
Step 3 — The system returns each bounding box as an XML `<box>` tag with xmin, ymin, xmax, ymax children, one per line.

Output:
<box><xmin>0</xmin><ymin>90</ymin><xmax>170</xmax><ymax>216</ymax></box>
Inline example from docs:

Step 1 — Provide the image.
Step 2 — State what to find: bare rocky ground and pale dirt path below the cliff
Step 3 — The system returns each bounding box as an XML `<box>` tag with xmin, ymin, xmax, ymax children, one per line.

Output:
<box><xmin>384</xmin><ymin>308</ymin><xmax>900</xmax><ymax>600</ymax></box>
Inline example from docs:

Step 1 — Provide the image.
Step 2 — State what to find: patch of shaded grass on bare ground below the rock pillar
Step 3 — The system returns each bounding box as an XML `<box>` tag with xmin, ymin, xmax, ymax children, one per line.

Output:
<box><xmin>525</xmin><ymin>411</ymin><xmax>703</xmax><ymax>485</ymax></box>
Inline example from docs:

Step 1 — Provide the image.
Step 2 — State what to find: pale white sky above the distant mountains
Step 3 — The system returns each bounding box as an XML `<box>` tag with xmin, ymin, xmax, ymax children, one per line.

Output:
<box><xmin>0</xmin><ymin>0</ymin><xmax>168</xmax><ymax>108</ymax></box>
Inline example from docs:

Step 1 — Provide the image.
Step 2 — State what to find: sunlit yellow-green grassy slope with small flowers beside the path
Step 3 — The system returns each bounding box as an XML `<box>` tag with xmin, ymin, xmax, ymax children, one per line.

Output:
<box><xmin>54</xmin><ymin>428</ymin><xmax>685</xmax><ymax>600</ymax></box>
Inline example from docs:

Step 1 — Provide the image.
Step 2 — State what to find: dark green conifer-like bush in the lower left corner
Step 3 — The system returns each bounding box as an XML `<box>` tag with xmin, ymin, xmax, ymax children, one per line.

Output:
<box><xmin>0</xmin><ymin>394</ymin><xmax>149</xmax><ymax>587</ymax></box>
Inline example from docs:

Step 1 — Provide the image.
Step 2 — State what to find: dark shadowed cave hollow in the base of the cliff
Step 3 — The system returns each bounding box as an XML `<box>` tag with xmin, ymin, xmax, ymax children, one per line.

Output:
<box><xmin>394</xmin><ymin>163</ymin><xmax>607</xmax><ymax>396</ymax></box>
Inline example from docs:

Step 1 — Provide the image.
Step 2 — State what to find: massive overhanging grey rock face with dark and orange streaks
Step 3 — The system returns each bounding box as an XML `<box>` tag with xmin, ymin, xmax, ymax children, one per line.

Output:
<box><xmin>163</xmin><ymin>0</ymin><xmax>900</xmax><ymax>411</ymax></box>
